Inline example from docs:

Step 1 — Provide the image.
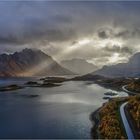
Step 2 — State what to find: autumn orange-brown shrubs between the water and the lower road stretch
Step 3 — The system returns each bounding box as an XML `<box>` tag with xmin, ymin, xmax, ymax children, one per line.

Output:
<box><xmin>98</xmin><ymin>98</ymin><xmax>126</xmax><ymax>139</ymax></box>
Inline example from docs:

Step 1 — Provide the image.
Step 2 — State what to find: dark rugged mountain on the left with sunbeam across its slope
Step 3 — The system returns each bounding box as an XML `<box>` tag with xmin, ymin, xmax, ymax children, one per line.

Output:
<box><xmin>0</xmin><ymin>49</ymin><xmax>72</xmax><ymax>76</ymax></box>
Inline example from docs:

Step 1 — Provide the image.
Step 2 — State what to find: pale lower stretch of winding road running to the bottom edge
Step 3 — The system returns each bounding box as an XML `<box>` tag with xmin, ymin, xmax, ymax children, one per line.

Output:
<box><xmin>120</xmin><ymin>102</ymin><xmax>135</xmax><ymax>139</ymax></box>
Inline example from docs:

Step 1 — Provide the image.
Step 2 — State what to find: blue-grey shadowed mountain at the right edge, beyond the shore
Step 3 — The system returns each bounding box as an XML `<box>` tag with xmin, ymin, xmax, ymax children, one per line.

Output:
<box><xmin>92</xmin><ymin>53</ymin><xmax>140</xmax><ymax>77</ymax></box>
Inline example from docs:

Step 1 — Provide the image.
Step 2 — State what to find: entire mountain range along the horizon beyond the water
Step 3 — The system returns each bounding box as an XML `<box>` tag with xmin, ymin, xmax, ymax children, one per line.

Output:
<box><xmin>0</xmin><ymin>48</ymin><xmax>140</xmax><ymax>77</ymax></box>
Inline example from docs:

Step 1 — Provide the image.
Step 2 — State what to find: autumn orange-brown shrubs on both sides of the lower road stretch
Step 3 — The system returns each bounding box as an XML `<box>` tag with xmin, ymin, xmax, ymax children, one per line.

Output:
<box><xmin>94</xmin><ymin>94</ymin><xmax>140</xmax><ymax>139</ymax></box>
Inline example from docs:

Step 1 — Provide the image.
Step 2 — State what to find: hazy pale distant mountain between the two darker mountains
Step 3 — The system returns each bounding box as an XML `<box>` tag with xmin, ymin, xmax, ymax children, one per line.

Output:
<box><xmin>61</xmin><ymin>59</ymin><xmax>97</xmax><ymax>74</ymax></box>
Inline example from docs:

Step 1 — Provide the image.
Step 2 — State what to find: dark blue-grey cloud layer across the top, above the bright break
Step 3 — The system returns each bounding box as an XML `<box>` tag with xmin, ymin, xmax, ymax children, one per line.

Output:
<box><xmin>0</xmin><ymin>1</ymin><xmax>140</xmax><ymax>43</ymax></box>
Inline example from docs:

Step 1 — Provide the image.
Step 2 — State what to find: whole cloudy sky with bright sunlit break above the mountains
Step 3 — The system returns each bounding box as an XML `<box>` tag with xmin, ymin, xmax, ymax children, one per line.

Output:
<box><xmin>0</xmin><ymin>0</ymin><xmax>140</xmax><ymax>67</ymax></box>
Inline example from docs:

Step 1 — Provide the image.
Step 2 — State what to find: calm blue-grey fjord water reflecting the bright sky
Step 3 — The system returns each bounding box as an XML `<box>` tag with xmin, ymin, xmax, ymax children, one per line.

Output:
<box><xmin>0</xmin><ymin>78</ymin><xmax>127</xmax><ymax>138</ymax></box>
